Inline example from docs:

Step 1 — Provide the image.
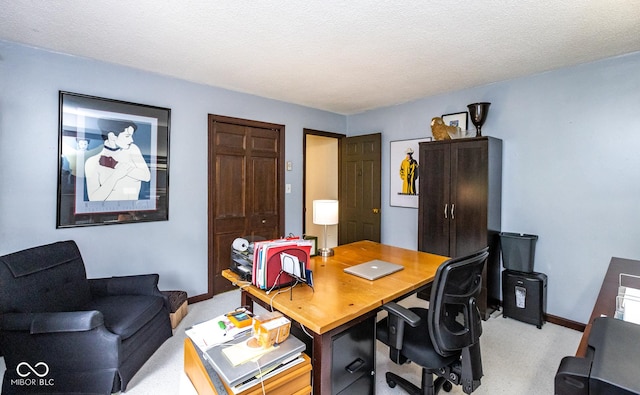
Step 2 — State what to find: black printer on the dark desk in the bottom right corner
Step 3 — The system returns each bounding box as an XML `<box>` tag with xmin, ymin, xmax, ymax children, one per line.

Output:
<box><xmin>554</xmin><ymin>317</ymin><xmax>640</xmax><ymax>395</ymax></box>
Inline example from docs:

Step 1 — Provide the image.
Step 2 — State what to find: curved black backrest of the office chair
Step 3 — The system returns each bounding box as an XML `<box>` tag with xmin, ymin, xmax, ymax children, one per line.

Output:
<box><xmin>428</xmin><ymin>251</ymin><xmax>489</xmax><ymax>356</ymax></box>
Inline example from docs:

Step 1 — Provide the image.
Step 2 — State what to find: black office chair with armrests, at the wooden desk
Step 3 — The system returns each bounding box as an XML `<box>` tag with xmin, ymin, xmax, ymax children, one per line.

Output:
<box><xmin>376</xmin><ymin>247</ymin><xmax>489</xmax><ymax>395</ymax></box>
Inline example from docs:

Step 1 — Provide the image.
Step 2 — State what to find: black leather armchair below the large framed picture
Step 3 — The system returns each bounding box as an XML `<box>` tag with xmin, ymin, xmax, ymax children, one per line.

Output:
<box><xmin>0</xmin><ymin>241</ymin><xmax>172</xmax><ymax>394</ymax></box>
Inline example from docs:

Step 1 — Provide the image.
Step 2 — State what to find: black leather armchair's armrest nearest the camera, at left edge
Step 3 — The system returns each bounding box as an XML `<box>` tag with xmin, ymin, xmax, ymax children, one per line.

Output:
<box><xmin>0</xmin><ymin>310</ymin><xmax>104</xmax><ymax>334</ymax></box>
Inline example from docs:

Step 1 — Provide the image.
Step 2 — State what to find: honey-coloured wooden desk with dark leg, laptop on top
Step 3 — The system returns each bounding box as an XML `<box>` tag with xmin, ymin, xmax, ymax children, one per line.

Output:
<box><xmin>222</xmin><ymin>241</ymin><xmax>448</xmax><ymax>394</ymax></box>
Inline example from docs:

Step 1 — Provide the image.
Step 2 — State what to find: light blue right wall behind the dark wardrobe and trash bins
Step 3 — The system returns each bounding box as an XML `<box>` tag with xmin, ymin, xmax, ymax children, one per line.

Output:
<box><xmin>348</xmin><ymin>53</ymin><xmax>640</xmax><ymax>323</ymax></box>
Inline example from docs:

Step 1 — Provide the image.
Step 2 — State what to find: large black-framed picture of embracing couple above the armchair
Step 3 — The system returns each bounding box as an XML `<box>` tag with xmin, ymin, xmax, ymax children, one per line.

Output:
<box><xmin>56</xmin><ymin>91</ymin><xmax>171</xmax><ymax>228</ymax></box>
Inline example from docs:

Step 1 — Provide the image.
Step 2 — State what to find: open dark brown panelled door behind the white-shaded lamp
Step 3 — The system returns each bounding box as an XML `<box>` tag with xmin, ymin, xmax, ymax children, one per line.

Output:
<box><xmin>338</xmin><ymin>133</ymin><xmax>381</xmax><ymax>244</ymax></box>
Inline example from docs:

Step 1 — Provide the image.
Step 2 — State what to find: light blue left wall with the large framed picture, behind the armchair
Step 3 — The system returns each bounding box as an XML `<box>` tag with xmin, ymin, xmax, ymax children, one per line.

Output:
<box><xmin>0</xmin><ymin>41</ymin><xmax>346</xmax><ymax>296</ymax></box>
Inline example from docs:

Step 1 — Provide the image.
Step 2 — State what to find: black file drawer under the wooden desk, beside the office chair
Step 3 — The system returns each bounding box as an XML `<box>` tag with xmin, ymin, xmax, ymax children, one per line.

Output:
<box><xmin>331</xmin><ymin>316</ymin><xmax>376</xmax><ymax>394</ymax></box>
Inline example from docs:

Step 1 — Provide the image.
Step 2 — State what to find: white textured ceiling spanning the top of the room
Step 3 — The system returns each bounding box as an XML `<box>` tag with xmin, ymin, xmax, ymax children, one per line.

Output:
<box><xmin>0</xmin><ymin>0</ymin><xmax>640</xmax><ymax>114</ymax></box>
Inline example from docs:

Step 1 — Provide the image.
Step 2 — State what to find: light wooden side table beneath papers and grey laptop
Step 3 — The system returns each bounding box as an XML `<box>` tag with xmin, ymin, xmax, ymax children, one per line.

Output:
<box><xmin>184</xmin><ymin>337</ymin><xmax>312</xmax><ymax>395</ymax></box>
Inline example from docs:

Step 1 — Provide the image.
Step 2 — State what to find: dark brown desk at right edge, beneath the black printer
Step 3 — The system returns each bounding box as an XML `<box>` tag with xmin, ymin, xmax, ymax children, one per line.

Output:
<box><xmin>576</xmin><ymin>257</ymin><xmax>640</xmax><ymax>357</ymax></box>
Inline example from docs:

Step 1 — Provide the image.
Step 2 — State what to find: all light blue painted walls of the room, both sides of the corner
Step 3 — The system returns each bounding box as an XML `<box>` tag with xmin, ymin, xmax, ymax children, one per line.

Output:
<box><xmin>0</xmin><ymin>41</ymin><xmax>640</xmax><ymax>322</ymax></box>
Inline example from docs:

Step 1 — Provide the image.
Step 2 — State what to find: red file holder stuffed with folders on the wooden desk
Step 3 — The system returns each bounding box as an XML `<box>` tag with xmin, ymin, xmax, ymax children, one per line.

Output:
<box><xmin>252</xmin><ymin>238</ymin><xmax>312</xmax><ymax>290</ymax></box>
